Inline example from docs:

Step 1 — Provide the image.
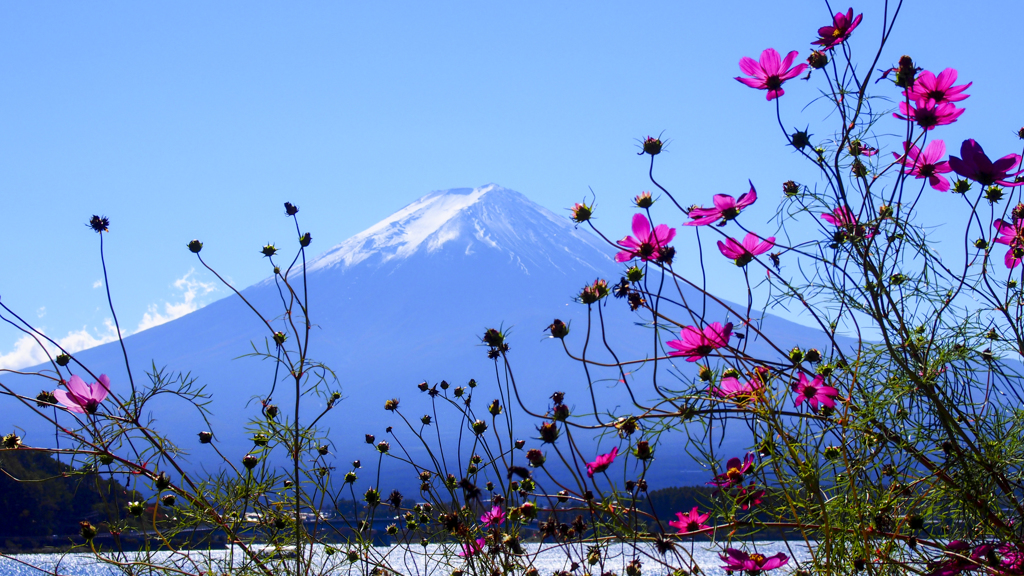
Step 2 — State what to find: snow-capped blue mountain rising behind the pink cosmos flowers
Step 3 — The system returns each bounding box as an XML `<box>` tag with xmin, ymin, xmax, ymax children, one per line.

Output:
<box><xmin>9</xmin><ymin>184</ymin><xmax>821</xmax><ymax>493</ymax></box>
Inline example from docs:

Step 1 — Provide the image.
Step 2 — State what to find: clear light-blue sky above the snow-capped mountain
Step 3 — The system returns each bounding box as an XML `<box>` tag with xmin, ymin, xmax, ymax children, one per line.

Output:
<box><xmin>0</xmin><ymin>0</ymin><xmax>1024</xmax><ymax>365</ymax></box>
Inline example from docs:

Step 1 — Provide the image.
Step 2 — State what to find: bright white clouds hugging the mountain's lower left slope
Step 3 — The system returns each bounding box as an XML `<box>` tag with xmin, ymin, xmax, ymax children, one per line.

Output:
<box><xmin>0</xmin><ymin>269</ymin><xmax>217</xmax><ymax>370</ymax></box>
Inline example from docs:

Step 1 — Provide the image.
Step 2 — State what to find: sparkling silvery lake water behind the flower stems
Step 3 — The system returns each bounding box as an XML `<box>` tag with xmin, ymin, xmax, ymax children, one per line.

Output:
<box><xmin>6</xmin><ymin>542</ymin><xmax>806</xmax><ymax>576</ymax></box>
